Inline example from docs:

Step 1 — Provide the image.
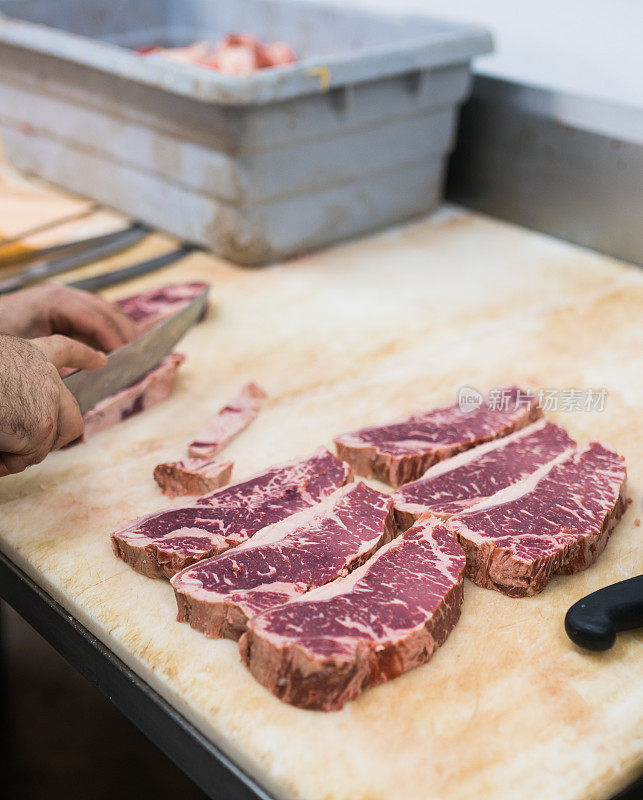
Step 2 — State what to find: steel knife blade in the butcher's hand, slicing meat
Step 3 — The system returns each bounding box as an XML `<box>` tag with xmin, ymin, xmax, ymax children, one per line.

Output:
<box><xmin>63</xmin><ymin>287</ymin><xmax>210</xmax><ymax>414</ymax></box>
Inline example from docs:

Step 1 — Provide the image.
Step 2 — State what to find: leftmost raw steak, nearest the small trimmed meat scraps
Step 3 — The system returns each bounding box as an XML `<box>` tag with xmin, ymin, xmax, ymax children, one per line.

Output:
<box><xmin>112</xmin><ymin>447</ymin><xmax>352</xmax><ymax>578</ymax></box>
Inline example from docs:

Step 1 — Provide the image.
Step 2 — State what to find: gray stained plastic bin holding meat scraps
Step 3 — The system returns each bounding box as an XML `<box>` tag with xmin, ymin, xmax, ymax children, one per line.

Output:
<box><xmin>0</xmin><ymin>0</ymin><xmax>491</xmax><ymax>264</ymax></box>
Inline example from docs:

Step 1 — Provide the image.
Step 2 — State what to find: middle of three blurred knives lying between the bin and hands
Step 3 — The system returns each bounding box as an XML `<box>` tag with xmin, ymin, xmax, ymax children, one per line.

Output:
<box><xmin>0</xmin><ymin>223</ymin><xmax>149</xmax><ymax>294</ymax></box>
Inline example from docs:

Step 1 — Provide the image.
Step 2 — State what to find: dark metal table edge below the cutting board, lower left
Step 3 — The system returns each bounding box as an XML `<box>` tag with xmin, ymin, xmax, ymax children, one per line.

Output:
<box><xmin>0</xmin><ymin>553</ymin><xmax>276</xmax><ymax>800</ymax></box>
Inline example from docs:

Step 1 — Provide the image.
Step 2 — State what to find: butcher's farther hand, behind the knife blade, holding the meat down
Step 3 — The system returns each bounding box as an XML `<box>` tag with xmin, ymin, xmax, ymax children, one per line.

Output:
<box><xmin>0</xmin><ymin>283</ymin><xmax>138</xmax><ymax>353</ymax></box>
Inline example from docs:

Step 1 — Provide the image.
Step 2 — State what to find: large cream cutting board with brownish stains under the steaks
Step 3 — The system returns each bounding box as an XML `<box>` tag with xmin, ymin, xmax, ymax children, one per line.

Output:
<box><xmin>0</xmin><ymin>177</ymin><xmax>643</xmax><ymax>800</ymax></box>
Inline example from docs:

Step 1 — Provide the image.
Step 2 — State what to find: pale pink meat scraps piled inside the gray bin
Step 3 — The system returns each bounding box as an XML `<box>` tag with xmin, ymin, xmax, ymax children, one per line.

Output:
<box><xmin>137</xmin><ymin>33</ymin><xmax>297</xmax><ymax>75</ymax></box>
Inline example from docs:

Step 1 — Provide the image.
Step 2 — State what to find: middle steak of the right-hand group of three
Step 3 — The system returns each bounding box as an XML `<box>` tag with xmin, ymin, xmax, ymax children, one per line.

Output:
<box><xmin>393</xmin><ymin>419</ymin><xmax>575</xmax><ymax>530</ymax></box>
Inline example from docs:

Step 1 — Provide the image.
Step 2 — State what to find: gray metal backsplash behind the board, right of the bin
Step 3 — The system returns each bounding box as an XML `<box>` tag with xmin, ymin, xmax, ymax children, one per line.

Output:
<box><xmin>447</xmin><ymin>76</ymin><xmax>643</xmax><ymax>266</ymax></box>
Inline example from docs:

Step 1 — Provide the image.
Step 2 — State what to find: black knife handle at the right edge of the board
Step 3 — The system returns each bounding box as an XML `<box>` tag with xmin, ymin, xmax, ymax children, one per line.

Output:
<box><xmin>565</xmin><ymin>575</ymin><xmax>643</xmax><ymax>650</ymax></box>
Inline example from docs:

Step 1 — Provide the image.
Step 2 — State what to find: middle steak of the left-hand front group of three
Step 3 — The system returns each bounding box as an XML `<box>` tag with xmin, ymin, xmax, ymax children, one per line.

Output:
<box><xmin>171</xmin><ymin>482</ymin><xmax>397</xmax><ymax>639</ymax></box>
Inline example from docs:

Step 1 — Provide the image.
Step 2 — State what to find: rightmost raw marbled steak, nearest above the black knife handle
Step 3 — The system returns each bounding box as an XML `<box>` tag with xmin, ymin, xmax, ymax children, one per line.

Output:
<box><xmin>445</xmin><ymin>442</ymin><xmax>627</xmax><ymax>597</ymax></box>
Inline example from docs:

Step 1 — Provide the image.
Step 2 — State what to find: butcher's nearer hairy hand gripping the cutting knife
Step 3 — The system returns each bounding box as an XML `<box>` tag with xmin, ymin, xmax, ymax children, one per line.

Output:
<box><xmin>0</xmin><ymin>334</ymin><xmax>107</xmax><ymax>477</ymax></box>
